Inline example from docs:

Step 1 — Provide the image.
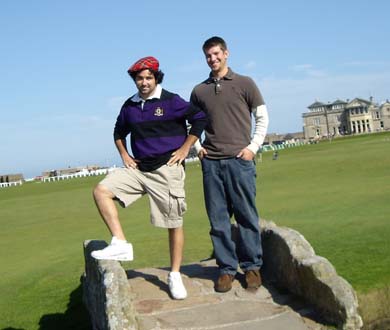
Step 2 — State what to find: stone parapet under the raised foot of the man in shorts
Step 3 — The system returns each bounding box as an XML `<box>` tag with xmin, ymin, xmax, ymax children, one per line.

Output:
<box><xmin>82</xmin><ymin>241</ymin><xmax>138</xmax><ymax>330</ymax></box>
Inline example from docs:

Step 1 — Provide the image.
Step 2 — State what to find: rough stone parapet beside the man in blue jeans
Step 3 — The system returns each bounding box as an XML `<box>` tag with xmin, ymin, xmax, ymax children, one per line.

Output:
<box><xmin>261</xmin><ymin>221</ymin><xmax>363</xmax><ymax>330</ymax></box>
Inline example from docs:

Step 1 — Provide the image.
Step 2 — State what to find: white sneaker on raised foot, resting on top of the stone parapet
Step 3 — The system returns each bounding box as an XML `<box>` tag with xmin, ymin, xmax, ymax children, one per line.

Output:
<box><xmin>91</xmin><ymin>237</ymin><xmax>133</xmax><ymax>261</ymax></box>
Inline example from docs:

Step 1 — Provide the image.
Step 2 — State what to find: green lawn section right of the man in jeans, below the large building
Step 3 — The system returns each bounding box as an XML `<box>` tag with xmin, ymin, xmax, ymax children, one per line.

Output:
<box><xmin>258</xmin><ymin>133</ymin><xmax>390</xmax><ymax>292</ymax></box>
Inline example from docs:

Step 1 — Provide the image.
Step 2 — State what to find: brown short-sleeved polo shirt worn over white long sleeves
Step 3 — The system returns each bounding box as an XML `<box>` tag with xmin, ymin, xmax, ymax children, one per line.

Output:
<box><xmin>191</xmin><ymin>68</ymin><xmax>265</xmax><ymax>159</ymax></box>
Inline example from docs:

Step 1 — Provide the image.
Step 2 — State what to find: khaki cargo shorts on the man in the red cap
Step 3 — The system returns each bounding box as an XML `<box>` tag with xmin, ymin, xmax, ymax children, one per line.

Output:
<box><xmin>100</xmin><ymin>164</ymin><xmax>187</xmax><ymax>228</ymax></box>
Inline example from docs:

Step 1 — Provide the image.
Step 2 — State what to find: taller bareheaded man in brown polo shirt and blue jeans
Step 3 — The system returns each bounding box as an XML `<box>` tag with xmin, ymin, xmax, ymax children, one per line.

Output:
<box><xmin>191</xmin><ymin>37</ymin><xmax>268</xmax><ymax>292</ymax></box>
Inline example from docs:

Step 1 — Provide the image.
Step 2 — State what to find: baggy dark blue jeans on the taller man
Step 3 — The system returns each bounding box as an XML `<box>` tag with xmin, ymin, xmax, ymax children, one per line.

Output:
<box><xmin>202</xmin><ymin>158</ymin><xmax>263</xmax><ymax>275</ymax></box>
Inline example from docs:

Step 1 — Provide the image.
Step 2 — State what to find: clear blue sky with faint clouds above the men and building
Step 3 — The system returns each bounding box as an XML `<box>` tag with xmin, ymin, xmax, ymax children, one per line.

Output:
<box><xmin>0</xmin><ymin>0</ymin><xmax>390</xmax><ymax>178</ymax></box>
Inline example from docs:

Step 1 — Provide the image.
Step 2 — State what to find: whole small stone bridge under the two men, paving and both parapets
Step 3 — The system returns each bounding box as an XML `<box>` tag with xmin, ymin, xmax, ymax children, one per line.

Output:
<box><xmin>83</xmin><ymin>222</ymin><xmax>362</xmax><ymax>330</ymax></box>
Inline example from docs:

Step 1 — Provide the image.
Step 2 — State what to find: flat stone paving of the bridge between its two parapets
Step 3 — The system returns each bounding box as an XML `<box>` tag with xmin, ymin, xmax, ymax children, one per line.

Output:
<box><xmin>126</xmin><ymin>260</ymin><xmax>322</xmax><ymax>330</ymax></box>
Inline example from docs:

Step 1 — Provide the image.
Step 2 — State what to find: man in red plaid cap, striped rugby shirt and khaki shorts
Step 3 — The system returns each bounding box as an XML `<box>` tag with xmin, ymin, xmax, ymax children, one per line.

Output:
<box><xmin>91</xmin><ymin>56</ymin><xmax>206</xmax><ymax>299</ymax></box>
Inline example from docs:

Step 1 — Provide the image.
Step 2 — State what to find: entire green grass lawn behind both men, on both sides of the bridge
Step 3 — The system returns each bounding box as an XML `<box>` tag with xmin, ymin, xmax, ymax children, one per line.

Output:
<box><xmin>0</xmin><ymin>133</ymin><xmax>390</xmax><ymax>330</ymax></box>
